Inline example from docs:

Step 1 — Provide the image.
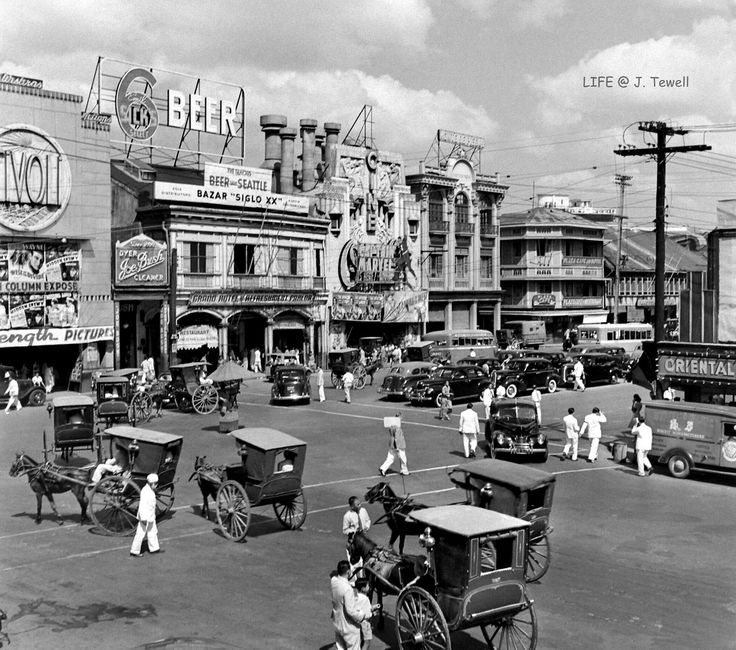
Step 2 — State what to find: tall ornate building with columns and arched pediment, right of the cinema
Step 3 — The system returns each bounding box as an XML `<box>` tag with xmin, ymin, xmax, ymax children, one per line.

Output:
<box><xmin>406</xmin><ymin>134</ymin><xmax>508</xmax><ymax>331</ymax></box>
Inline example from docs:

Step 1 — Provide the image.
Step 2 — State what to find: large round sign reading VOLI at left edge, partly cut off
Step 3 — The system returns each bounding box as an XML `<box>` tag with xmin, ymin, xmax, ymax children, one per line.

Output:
<box><xmin>0</xmin><ymin>124</ymin><xmax>72</xmax><ymax>232</ymax></box>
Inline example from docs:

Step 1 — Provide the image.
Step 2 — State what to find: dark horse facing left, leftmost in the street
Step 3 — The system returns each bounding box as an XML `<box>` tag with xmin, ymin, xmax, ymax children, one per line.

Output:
<box><xmin>10</xmin><ymin>453</ymin><xmax>89</xmax><ymax>526</ymax></box>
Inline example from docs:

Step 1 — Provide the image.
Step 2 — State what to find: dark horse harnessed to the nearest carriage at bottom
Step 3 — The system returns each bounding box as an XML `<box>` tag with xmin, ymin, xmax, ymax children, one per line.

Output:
<box><xmin>348</xmin><ymin>531</ymin><xmax>434</xmax><ymax>627</ymax></box>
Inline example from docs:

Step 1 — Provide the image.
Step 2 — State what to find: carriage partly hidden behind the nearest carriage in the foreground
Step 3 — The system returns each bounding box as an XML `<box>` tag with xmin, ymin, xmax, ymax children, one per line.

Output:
<box><xmin>450</xmin><ymin>459</ymin><xmax>555</xmax><ymax>582</ymax></box>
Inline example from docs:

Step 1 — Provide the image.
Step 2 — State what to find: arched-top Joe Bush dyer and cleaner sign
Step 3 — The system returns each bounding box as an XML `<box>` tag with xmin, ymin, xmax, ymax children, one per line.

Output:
<box><xmin>114</xmin><ymin>235</ymin><xmax>169</xmax><ymax>287</ymax></box>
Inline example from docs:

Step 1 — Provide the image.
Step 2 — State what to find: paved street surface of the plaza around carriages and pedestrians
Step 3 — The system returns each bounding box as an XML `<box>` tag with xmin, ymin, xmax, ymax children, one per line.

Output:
<box><xmin>0</xmin><ymin>375</ymin><xmax>736</xmax><ymax>650</ymax></box>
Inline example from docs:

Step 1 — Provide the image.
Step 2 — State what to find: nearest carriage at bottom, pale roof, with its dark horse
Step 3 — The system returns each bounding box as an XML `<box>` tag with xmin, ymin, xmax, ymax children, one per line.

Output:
<box><xmin>350</xmin><ymin>505</ymin><xmax>537</xmax><ymax>650</ymax></box>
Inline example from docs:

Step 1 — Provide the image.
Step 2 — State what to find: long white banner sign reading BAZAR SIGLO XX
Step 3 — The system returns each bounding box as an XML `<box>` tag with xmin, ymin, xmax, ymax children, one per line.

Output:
<box><xmin>153</xmin><ymin>181</ymin><xmax>309</xmax><ymax>214</ymax></box>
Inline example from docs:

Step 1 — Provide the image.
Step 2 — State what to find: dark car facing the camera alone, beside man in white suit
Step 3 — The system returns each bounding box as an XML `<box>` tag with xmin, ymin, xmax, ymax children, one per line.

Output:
<box><xmin>485</xmin><ymin>399</ymin><xmax>549</xmax><ymax>462</ymax></box>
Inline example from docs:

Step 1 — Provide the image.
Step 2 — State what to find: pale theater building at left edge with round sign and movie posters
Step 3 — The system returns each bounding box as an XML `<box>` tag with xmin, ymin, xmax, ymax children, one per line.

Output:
<box><xmin>0</xmin><ymin>75</ymin><xmax>114</xmax><ymax>389</ymax></box>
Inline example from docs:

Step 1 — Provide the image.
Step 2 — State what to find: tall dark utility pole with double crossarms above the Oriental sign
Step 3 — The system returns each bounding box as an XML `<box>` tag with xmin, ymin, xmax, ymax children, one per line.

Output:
<box><xmin>613</xmin><ymin>122</ymin><xmax>712</xmax><ymax>341</ymax></box>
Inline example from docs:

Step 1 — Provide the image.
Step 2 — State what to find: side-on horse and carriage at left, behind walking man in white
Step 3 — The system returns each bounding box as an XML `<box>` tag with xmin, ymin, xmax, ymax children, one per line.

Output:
<box><xmin>10</xmin><ymin>422</ymin><xmax>183</xmax><ymax>535</ymax></box>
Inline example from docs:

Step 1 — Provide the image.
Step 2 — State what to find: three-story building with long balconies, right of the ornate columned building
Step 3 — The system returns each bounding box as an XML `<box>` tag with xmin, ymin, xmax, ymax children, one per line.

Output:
<box><xmin>500</xmin><ymin>208</ymin><xmax>608</xmax><ymax>341</ymax></box>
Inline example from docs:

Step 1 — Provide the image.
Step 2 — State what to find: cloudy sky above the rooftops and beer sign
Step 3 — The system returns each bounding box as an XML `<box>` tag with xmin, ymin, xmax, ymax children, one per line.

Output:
<box><xmin>0</xmin><ymin>0</ymin><xmax>736</xmax><ymax>230</ymax></box>
